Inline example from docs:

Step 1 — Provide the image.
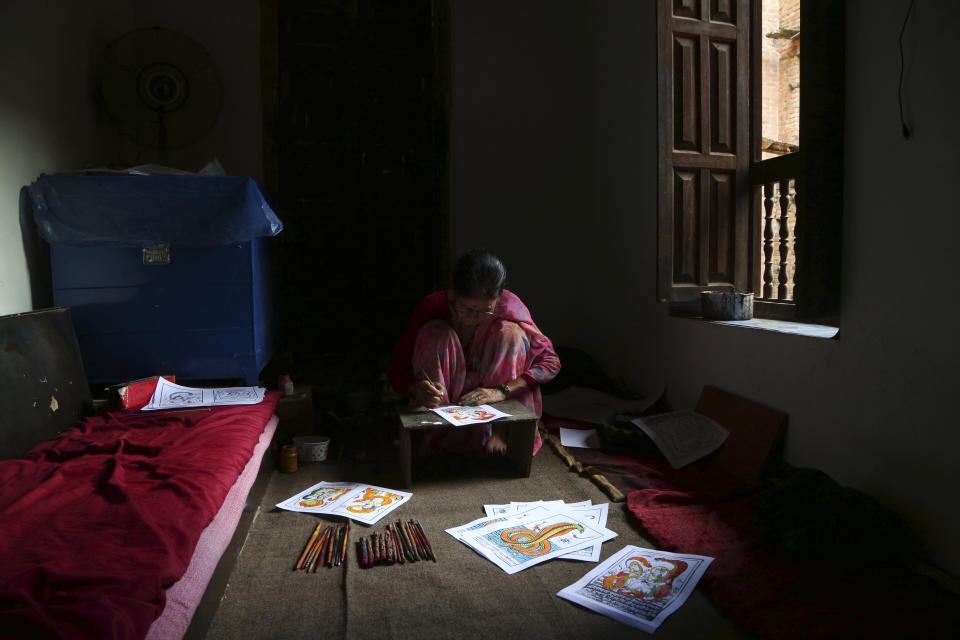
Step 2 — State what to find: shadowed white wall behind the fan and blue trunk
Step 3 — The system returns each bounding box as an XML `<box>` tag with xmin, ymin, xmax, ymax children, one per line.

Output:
<box><xmin>0</xmin><ymin>0</ymin><xmax>262</xmax><ymax>315</ymax></box>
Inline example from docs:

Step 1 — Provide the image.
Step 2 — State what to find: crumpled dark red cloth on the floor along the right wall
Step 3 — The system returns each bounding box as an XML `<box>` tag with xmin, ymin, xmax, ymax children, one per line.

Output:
<box><xmin>627</xmin><ymin>489</ymin><xmax>960</xmax><ymax>640</ymax></box>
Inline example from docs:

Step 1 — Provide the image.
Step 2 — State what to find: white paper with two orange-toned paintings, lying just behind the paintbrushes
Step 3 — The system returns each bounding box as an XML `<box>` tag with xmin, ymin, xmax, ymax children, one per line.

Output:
<box><xmin>277</xmin><ymin>482</ymin><xmax>413</xmax><ymax>524</ymax></box>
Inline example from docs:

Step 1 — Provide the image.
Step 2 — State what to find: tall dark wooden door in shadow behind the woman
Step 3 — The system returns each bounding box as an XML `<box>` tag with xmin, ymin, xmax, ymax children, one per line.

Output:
<box><xmin>264</xmin><ymin>0</ymin><xmax>449</xmax><ymax>375</ymax></box>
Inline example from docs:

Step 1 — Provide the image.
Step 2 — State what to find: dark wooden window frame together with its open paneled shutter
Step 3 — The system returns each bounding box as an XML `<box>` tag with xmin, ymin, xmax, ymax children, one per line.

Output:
<box><xmin>657</xmin><ymin>0</ymin><xmax>845</xmax><ymax>325</ymax></box>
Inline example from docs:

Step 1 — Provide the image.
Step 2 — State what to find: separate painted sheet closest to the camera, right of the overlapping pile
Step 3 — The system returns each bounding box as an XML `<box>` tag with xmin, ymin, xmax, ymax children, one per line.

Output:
<box><xmin>557</xmin><ymin>545</ymin><xmax>713</xmax><ymax>633</ymax></box>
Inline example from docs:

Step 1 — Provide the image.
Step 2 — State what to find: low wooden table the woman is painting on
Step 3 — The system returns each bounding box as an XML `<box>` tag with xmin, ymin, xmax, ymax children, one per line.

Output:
<box><xmin>397</xmin><ymin>400</ymin><xmax>537</xmax><ymax>489</ymax></box>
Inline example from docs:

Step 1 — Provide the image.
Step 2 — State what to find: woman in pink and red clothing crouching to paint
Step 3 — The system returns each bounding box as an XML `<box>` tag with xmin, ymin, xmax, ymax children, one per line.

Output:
<box><xmin>388</xmin><ymin>249</ymin><xmax>560</xmax><ymax>453</ymax></box>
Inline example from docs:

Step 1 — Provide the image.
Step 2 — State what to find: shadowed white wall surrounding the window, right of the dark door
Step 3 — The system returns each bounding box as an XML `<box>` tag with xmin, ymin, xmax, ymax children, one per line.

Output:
<box><xmin>452</xmin><ymin>0</ymin><xmax>960</xmax><ymax>573</ymax></box>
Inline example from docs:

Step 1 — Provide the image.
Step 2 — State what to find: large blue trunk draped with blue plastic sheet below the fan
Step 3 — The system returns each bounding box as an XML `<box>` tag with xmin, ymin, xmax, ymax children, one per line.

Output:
<box><xmin>30</xmin><ymin>176</ymin><xmax>282</xmax><ymax>384</ymax></box>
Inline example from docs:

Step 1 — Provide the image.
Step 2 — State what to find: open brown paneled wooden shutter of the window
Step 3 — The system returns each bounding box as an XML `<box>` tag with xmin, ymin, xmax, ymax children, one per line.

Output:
<box><xmin>658</xmin><ymin>0</ymin><xmax>750</xmax><ymax>300</ymax></box>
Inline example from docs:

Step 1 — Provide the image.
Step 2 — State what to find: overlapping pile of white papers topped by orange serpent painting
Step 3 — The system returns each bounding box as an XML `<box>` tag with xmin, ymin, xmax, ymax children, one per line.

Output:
<box><xmin>447</xmin><ymin>500</ymin><xmax>617</xmax><ymax>574</ymax></box>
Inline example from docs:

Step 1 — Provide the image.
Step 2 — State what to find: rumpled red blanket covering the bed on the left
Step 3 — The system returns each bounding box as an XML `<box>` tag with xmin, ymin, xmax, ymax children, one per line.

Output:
<box><xmin>0</xmin><ymin>393</ymin><xmax>280</xmax><ymax>640</ymax></box>
